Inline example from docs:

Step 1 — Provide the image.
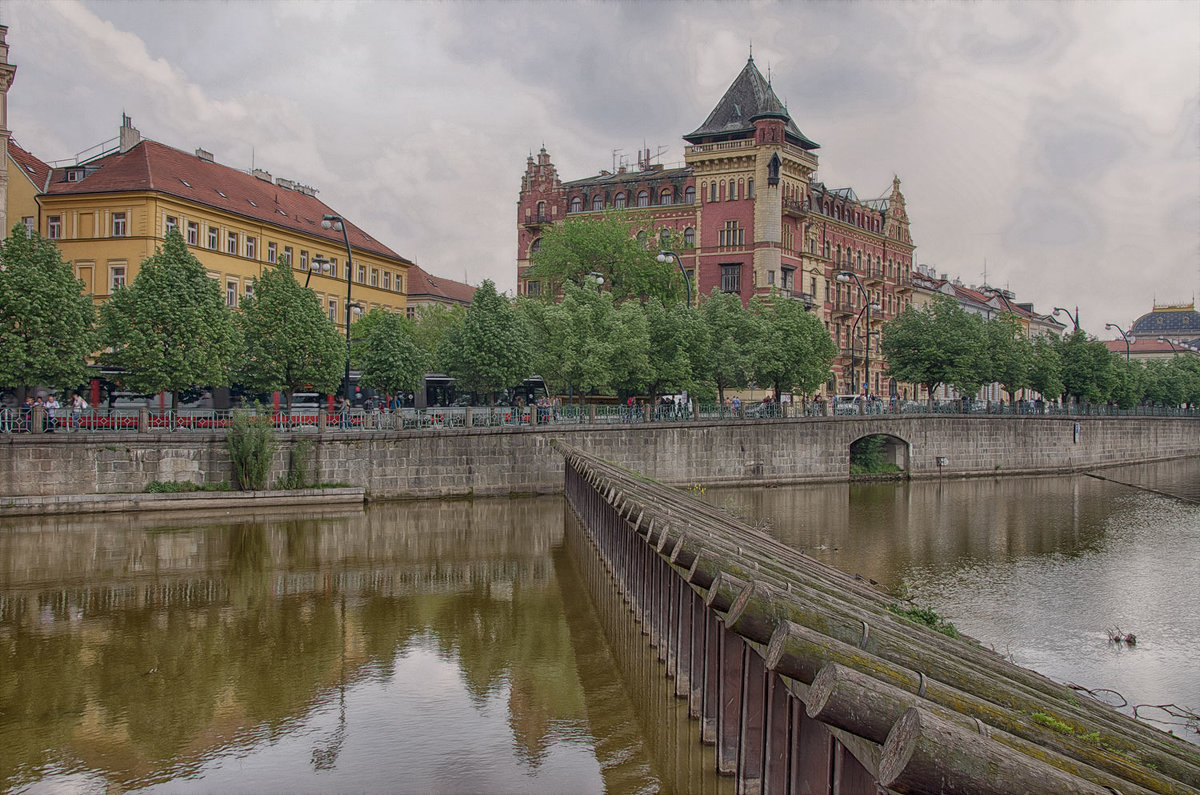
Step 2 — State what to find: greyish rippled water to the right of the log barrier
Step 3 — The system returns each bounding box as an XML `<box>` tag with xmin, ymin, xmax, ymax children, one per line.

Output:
<box><xmin>706</xmin><ymin>459</ymin><xmax>1200</xmax><ymax>741</ymax></box>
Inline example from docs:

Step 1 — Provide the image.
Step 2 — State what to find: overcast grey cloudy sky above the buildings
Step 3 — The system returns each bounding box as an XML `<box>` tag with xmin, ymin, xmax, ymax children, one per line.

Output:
<box><xmin>0</xmin><ymin>0</ymin><xmax>1200</xmax><ymax>337</ymax></box>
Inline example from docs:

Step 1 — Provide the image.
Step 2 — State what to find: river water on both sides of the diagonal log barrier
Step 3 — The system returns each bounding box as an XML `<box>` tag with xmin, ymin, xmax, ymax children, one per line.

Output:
<box><xmin>7</xmin><ymin>460</ymin><xmax>1200</xmax><ymax>793</ymax></box>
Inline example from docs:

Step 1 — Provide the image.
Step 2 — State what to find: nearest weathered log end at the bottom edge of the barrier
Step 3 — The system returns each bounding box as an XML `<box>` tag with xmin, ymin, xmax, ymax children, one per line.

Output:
<box><xmin>880</xmin><ymin>707</ymin><xmax>1112</xmax><ymax>795</ymax></box>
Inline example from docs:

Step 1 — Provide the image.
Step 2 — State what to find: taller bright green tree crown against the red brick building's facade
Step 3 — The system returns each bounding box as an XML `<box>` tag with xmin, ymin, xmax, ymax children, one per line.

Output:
<box><xmin>526</xmin><ymin>213</ymin><xmax>684</xmax><ymax>306</ymax></box>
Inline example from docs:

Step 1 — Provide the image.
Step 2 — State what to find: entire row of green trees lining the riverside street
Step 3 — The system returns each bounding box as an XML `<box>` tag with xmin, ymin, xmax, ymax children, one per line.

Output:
<box><xmin>0</xmin><ymin>221</ymin><xmax>1200</xmax><ymax>406</ymax></box>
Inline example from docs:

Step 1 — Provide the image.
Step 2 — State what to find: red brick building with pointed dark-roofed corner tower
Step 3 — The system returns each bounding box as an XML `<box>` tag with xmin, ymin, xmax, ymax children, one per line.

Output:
<box><xmin>517</xmin><ymin>52</ymin><xmax>913</xmax><ymax>395</ymax></box>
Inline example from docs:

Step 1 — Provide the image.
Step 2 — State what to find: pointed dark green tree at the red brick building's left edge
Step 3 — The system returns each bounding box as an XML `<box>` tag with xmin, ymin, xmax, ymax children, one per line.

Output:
<box><xmin>443</xmin><ymin>280</ymin><xmax>530</xmax><ymax>402</ymax></box>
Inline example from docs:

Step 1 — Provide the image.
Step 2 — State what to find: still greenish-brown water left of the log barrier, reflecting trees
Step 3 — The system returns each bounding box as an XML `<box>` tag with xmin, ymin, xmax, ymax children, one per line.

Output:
<box><xmin>0</xmin><ymin>497</ymin><xmax>694</xmax><ymax>793</ymax></box>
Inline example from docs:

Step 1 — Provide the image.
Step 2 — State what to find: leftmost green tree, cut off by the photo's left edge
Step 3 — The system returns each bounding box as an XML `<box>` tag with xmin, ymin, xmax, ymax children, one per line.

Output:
<box><xmin>0</xmin><ymin>225</ymin><xmax>96</xmax><ymax>400</ymax></box>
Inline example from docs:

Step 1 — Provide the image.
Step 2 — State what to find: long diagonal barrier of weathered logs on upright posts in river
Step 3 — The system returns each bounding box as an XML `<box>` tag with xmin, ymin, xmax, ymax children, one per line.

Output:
<box><xmin>553</xmin><ymin>441</ymin><xmax>1200</xmax><ymax>795</ymax></box>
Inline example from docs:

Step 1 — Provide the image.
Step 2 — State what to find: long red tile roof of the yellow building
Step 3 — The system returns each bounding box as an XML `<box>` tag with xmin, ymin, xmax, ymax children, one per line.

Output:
<box><xmin>46</xmin><ymin>141</ymin><xmax>407</xmax><ymax>262</ymax></box>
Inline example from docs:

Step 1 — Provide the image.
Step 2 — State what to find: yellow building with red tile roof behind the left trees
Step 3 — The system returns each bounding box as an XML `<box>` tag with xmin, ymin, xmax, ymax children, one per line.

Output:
<box><xmin>35</xmin><ymin>116</ymin><xmax>413</xmax><ymax>325</ymax></box>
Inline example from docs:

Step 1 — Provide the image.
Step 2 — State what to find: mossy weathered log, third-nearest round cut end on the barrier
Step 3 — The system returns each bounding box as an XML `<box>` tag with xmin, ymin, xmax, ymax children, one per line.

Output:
<box><xmin>767</xmin><ymin>623</ymin><xmax>1190</xmax><ymax>795</ymax></box>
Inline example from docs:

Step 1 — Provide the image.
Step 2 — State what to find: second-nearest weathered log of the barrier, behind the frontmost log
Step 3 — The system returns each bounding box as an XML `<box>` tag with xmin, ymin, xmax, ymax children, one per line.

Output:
<box><xmin>805</xmin><ymin>663</ymin><xmax>1161</xmax><ymax>795</ymax></box>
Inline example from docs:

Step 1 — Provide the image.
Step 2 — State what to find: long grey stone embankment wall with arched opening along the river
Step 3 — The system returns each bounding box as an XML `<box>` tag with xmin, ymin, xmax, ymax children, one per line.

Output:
<box><xmin>0</xmin><ymin>416</ymin><xmax>1200</xmax><ymax>498</ymax></box>
